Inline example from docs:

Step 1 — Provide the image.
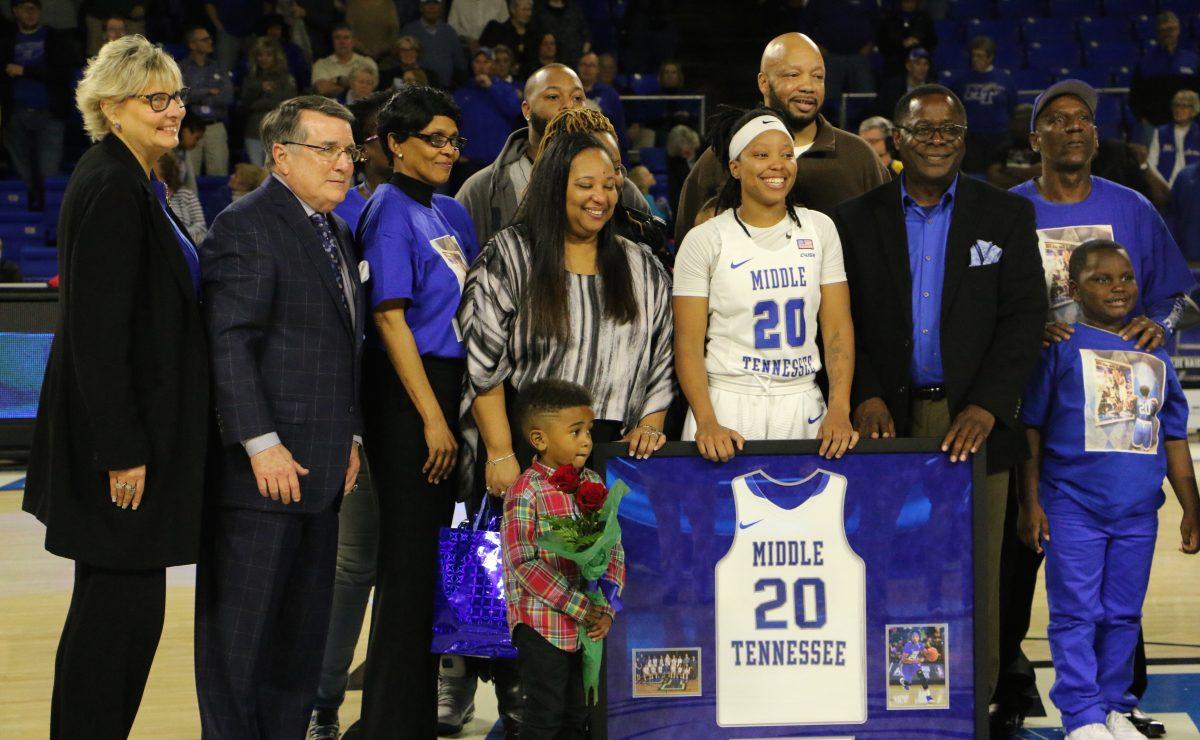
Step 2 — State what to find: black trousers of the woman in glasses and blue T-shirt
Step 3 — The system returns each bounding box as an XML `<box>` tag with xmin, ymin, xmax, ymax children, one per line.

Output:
<box><xmin>362</xmin><ymin>349</ymin><xmax>466</xmax><ymax>740</ymax></box>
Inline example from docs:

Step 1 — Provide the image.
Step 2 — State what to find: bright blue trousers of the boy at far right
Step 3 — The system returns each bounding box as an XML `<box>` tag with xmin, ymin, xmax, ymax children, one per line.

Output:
<box><xmin>1042</xmin><ymin>494</ymin><xmax>1158</xmax><ymax>733</ymax></box>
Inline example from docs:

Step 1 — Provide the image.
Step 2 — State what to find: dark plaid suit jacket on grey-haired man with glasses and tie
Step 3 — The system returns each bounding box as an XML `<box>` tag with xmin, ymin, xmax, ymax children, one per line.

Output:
<box><xmin>200</xmin><ymin>176</ymin><xmax>366</xmax><ymax>513</ymax></box>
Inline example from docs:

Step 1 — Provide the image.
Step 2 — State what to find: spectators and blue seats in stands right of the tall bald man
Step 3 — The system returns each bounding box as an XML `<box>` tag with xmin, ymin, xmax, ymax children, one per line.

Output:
<box><xmin>792</xmin><ymin>0</ymin><xmax>1200</xmax><ymax>260</ymax></box>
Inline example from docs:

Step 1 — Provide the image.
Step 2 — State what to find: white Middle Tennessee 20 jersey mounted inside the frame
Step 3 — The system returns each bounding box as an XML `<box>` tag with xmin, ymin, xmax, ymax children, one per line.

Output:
<box><xmin>715</xmin><ymin>470</ymin><xmax>866</xmax><ymax>727</ymax></box>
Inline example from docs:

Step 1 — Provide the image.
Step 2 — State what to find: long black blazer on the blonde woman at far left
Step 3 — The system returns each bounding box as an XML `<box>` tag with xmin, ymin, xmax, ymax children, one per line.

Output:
<box><xmin>23</xmin><ymin>136</ymin><xmax>209</xmax><ymax>568</ymax></box>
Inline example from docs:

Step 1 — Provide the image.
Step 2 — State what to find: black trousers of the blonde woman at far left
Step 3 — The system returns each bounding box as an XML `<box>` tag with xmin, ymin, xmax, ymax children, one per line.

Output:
<box><xmin>50</xmin><ymin>560</ymin><xmax>167</xmax><ymax>740</ymax></box>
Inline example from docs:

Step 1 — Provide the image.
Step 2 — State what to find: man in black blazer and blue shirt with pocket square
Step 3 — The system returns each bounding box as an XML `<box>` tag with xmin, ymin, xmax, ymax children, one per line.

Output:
<box><xmin>834</xmin><ymin>85</ymin><xmax>1046</xmax><ymax>703</ymax></box>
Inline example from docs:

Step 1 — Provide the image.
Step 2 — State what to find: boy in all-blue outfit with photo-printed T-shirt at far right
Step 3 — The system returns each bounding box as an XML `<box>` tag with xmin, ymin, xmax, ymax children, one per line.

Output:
<box><xmin>1020</xmin><ymin>240</ymin><xmax>1200</xmax><ymax>740</ymax></box>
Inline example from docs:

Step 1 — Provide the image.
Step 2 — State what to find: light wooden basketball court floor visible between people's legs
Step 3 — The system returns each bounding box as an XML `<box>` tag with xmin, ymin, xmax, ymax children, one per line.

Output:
<box><xmin>0</xmin><ymin>473</ymin><xmax>1200</xmax><ymax>740</ymax></box>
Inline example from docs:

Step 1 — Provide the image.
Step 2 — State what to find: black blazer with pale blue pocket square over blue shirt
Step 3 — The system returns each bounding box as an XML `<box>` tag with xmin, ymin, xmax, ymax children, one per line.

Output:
<box><xmin>834</xmin><ymin>176</ymin><xmax>1046</xmax><ymax>473</ymax></box>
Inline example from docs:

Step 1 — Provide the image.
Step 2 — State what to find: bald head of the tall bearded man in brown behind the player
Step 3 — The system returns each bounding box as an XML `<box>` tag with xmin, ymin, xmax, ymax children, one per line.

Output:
<box><xmin>758</xmin><ymin>31</ymin><xmax>826</xmax><ymax>133</ymax></box>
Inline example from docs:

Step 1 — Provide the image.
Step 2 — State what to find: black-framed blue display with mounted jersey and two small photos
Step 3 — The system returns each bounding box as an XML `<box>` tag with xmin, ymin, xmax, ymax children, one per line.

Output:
<box><xmin>594</xmin><ymin>439</ymin><xmax>1001</xmax><ymax>740</ymax></box>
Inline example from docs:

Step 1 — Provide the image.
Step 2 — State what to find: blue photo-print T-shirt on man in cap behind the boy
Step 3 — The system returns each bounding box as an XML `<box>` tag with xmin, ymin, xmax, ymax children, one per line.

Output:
<box><xmin>1012</xmin><ymin>176</ymin><xmax>1195</xmax><ymax>329</ymax></box>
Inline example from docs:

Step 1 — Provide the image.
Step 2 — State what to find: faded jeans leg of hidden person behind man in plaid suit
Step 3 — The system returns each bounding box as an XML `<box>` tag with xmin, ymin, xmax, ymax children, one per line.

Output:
<box><xmin>314</xmin><ymin>455</ymin><xmax>379</xmax><ymax>709</ymax></box>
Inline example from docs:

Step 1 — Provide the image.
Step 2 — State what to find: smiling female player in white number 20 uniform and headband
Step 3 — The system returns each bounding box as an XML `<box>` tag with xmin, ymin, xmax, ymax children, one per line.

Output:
<box><xmin>673</xmin><ymin>109</ymin><xmax>858</xmax><ymax>461</ymax></box>
